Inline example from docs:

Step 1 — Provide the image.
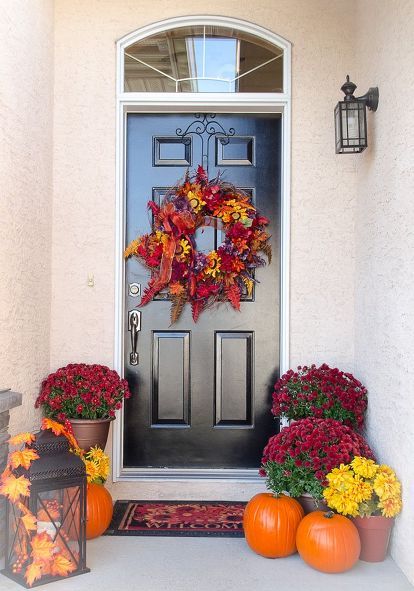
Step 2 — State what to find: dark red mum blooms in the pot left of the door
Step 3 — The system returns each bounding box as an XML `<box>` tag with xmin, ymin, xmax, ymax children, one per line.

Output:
<box><xmin>35</xmin><ymin>363</ymin><xmax>131</xmax><ymax>423</ymax></box>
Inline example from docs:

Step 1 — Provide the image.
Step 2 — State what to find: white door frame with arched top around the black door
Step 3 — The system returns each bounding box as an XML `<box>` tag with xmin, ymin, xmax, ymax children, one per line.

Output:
<box><xmin>112</xmin><ymin>16</ymin><xmax>291</xmax><ymax>482</ymax></box>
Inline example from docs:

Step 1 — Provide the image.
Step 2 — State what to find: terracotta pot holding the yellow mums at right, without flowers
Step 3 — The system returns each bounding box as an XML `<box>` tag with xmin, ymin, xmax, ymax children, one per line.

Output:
<box><xmin>352</xmin><ymin>515</ymin><xmax>394</xmax><ymax>562</ymax></box>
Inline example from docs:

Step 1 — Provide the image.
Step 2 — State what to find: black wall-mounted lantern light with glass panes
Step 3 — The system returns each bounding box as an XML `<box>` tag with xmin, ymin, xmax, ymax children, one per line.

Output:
<box><xmin>335</xmin><ymin>76</ymin><xmax>379</xmax><ymax>154</ymax></box>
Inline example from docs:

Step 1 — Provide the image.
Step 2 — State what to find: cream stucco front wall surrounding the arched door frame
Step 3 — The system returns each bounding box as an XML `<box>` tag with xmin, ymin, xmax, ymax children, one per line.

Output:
<box><xmin>51</xmin><ymin>0</ymin><xmax>355</xmax><ymax>498</ymax></box>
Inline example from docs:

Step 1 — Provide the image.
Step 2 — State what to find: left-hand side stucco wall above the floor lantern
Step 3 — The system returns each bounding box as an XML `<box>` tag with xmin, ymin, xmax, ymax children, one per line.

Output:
<box><xmin>0</xmin><ymin>0</ymin><xmax>53</xmax><ymax>433</ymax></box>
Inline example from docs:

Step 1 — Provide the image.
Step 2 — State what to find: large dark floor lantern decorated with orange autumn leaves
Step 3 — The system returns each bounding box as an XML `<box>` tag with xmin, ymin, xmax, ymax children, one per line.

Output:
<box><xmin>2</xmin><ymin>430</ymin><xmax>89</xmax><ymax>588</ymax></box>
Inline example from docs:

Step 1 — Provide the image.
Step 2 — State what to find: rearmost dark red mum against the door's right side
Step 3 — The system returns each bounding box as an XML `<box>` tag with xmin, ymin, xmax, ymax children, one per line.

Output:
<box><xmin>272</xmin><ymin>363</ymin><xmax>367</xmax><ymax>428</ymax></box>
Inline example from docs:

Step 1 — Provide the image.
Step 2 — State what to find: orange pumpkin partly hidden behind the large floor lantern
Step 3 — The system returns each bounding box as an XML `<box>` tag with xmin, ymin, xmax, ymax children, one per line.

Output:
<box><xmin>86</xmin><ymin>483</ymin><xmax>113</xmax><ymax>540</ymax></box>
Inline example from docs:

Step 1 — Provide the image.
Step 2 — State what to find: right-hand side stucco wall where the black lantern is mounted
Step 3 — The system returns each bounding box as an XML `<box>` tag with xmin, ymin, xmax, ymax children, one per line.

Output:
<box><xmin>352</xmin><ymin>0</ymin><xmax>414</xmax><ymax>581</ymax></box>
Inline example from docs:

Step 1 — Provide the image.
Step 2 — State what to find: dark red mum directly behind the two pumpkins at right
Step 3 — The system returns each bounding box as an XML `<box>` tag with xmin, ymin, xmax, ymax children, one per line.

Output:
<box><xmin>261</xmin><ymin>419</ymin><xmax>375</xmax><ymax>499</ymax></box>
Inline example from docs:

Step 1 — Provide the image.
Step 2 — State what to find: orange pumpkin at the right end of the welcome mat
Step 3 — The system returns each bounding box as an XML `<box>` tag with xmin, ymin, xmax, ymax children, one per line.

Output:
<box><xmin>243</xmin><ymin>493</ymin><xmax>303</xmax><ymax>558</ymax></box>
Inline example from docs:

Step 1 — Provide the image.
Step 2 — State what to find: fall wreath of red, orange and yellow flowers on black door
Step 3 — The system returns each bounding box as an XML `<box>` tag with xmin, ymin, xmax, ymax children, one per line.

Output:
<box><xmin>125</xmin><ymin>166</ymin><xmax>272</xmax><ymax>324</ymax></box>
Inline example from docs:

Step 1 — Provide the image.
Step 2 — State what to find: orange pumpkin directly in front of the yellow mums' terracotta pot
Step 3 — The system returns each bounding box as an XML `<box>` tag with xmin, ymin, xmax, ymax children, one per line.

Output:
<box><xmin>296</xmin><ymin>511</ymin><xmax>361</xmax><ymax>573</ymax></box>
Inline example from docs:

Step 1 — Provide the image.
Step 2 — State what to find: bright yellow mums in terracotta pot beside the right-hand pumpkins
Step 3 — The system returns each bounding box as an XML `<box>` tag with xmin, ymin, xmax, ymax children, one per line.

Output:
<box><xmin>323</xmin><ymin>456</ymin><xmax>402</xmax><ymax>517</ymax></box>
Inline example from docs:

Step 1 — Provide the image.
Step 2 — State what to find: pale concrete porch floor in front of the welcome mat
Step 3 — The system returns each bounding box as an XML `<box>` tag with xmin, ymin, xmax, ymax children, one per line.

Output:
<box><xmin>0</xmin><ymin>536</ymin><xmax>414</xmax><ymax>591</ymax></box>
